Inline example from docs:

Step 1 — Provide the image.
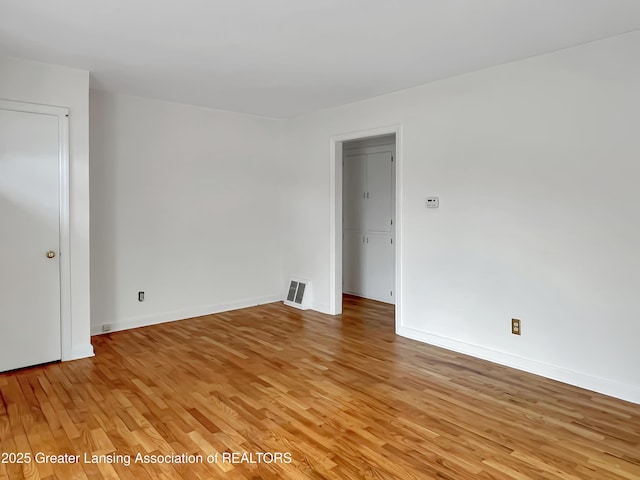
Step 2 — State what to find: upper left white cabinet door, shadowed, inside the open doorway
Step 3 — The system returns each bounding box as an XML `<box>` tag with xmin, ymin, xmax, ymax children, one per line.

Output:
<box><xmin>342</xmin><ymin>155</ymin><xmax>366</xmax><ymax>230</ymax></box>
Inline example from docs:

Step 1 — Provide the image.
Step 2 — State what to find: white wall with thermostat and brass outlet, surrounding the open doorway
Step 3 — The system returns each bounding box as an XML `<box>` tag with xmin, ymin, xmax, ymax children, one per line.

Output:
<box><xmin>284</xmin><ymin>32</ymin><xmax>640</xmax><ymax>403</ymax></box>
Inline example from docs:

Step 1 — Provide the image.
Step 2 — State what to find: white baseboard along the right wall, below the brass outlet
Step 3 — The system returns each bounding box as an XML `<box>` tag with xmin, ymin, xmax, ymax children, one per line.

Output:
<box><xmin>397</xmin><ymin>326</ymin><xmax>640</xmax><ymax>404</ymax></box>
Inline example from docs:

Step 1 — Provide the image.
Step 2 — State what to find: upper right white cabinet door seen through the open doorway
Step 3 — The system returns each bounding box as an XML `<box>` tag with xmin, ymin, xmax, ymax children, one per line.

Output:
<box><xmin>365</xmin><ymin>152</ymin><xmax>393</xmax><ymax>232</ymax></box>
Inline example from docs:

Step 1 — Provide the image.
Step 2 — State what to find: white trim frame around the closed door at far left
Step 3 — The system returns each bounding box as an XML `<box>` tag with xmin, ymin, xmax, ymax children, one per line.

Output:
<box><xmin>0</xmin><ymin>99</ymin><xmax>73</xmax><ymax>360</ymax></box>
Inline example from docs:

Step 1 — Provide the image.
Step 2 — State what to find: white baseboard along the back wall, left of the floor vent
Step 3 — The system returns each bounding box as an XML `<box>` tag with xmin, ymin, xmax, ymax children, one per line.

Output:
<box><xmin>91</xmin><ymin>295</ymin><xmax>282</xmax><ymax>335</ymax></box>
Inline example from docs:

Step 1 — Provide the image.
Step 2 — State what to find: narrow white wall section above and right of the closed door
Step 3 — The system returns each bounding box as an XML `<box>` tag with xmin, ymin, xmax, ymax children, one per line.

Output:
<box><xmin>0</xmin><ymin>57</ymin><xmax>93</xmax><ymax>360</ymax></box>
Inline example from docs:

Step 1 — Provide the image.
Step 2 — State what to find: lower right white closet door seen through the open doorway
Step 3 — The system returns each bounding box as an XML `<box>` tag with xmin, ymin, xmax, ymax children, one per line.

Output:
<box><xmin>365</xmin><ymin>233</ymin><xmax>395</xmax><ymax>303</ymax></box>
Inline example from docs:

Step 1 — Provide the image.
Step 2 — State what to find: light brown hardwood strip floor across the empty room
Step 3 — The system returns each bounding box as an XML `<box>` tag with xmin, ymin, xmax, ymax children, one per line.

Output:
<box><xmin>0</xmin><ymin>297</ymin><xmax>640</xmax><ymax>480</ymax></box>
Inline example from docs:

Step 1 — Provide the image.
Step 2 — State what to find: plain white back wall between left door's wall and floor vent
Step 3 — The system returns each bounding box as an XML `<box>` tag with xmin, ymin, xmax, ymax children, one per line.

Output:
<box><xmin>90</xmin><ymin>90</ymin><xmax>284</xmax><ymax>333</ymax></box>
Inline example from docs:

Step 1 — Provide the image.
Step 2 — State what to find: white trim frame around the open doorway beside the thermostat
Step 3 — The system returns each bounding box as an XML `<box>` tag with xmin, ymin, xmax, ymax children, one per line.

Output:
<box><xmin>329</xmin><ymin>124</ymin><xmax>402</xmax><ymax>332</ymax></box>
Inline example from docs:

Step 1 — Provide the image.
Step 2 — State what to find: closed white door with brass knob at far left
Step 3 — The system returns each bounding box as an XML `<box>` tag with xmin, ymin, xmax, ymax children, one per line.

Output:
<box><xmin>0</xmin><ymin>108</ymin><xmax>61</xmax><ymax>371</ymax></box>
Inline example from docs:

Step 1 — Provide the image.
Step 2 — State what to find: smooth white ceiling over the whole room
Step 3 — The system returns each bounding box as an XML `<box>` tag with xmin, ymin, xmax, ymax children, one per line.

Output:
<box><xmin>0</xmin><ymin>0</ymin><xmax>640</xmax><ymax>118</ymax></box>
